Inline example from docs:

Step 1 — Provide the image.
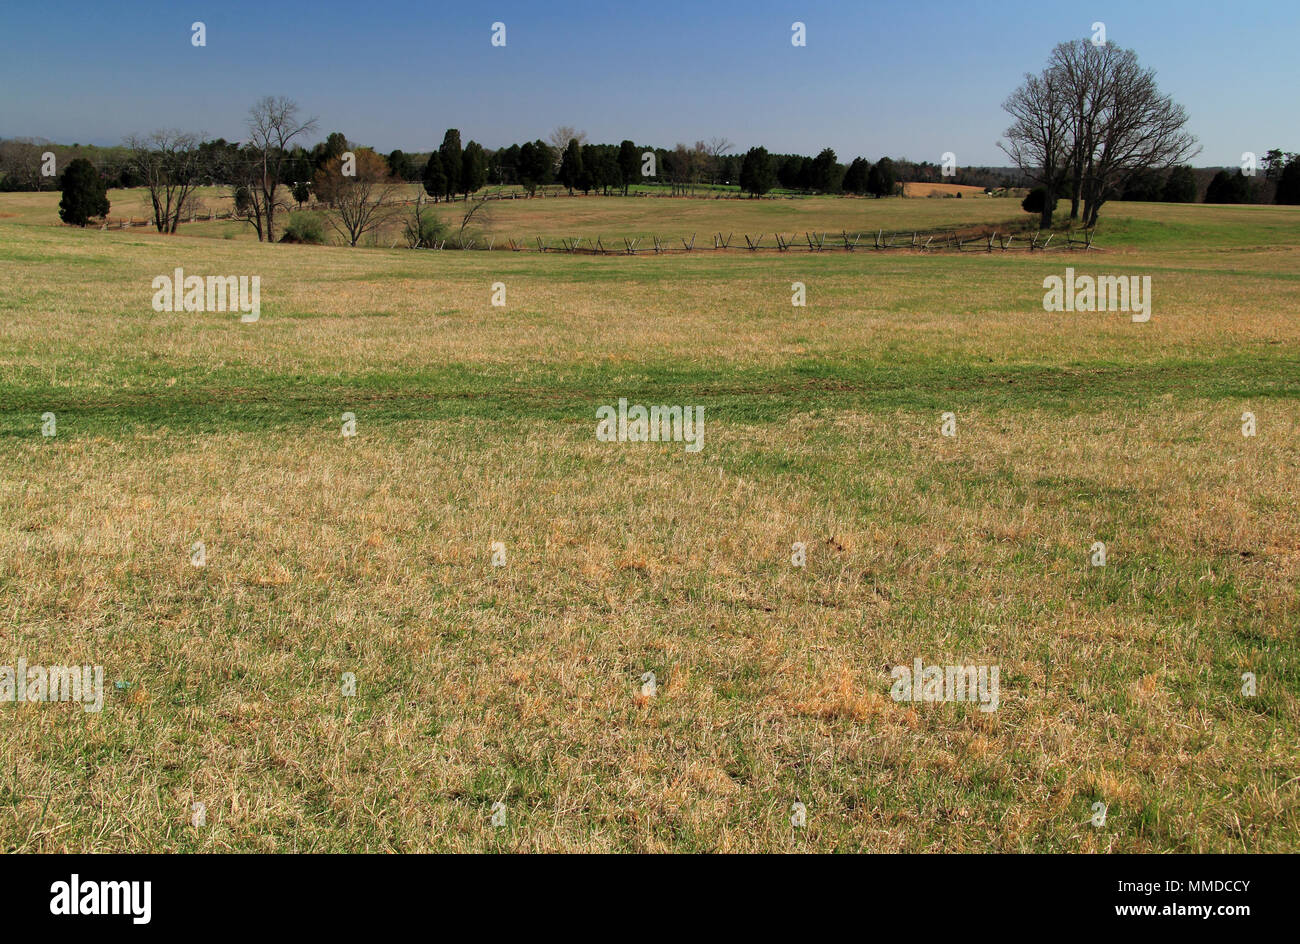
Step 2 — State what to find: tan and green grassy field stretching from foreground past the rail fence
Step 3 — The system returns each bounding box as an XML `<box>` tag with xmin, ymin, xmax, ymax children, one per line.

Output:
<box><xmin>0</xmin><ymin>194</ymin><xmax>1300</xmax><ymax>852</ymax></box>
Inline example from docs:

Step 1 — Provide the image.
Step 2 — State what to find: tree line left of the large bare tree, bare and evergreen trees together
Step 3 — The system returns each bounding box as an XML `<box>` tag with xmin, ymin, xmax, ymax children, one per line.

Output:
<box><xmin>22</xmin><ymin>98</ymin><xmax>1034</xmax><ymax>242</ymax></box>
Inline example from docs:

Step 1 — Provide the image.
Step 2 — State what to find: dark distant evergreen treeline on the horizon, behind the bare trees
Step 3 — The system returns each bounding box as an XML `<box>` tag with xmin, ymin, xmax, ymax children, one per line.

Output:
<box><xmin>0</xmin><ymin>129</ymin><xmax>1300</xmax><ymax>205</ymax></box>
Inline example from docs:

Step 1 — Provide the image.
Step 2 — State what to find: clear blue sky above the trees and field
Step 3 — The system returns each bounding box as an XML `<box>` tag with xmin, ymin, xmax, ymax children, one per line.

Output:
<box><xmin>0</xmin><ymin>0</ymin><xmax>1300</xmax><ymax>165</ymax></box>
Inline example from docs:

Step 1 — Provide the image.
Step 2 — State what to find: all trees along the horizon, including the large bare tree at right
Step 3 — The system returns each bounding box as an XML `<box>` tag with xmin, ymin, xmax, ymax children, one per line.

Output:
<box><xmin>35</xmin><ymin>47</ymin><xmax>1300</xmax><ymax>244</ymax></box>
